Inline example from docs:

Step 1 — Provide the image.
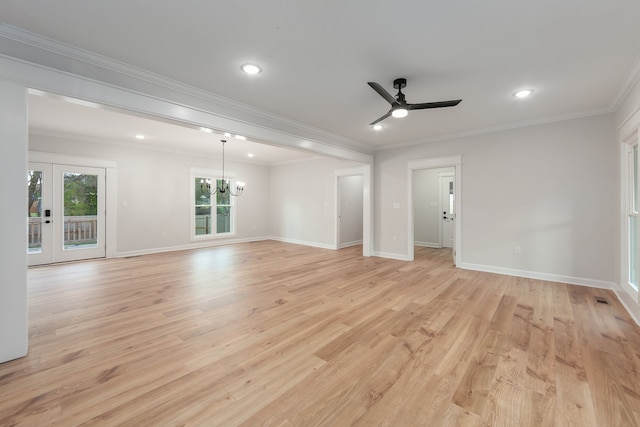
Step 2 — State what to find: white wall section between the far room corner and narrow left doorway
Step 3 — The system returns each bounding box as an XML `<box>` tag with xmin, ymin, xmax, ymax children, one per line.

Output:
<box><xmin>270</xmin><ymin>158</ymin><xmax>357</xmax><ymax>248</ymax></box>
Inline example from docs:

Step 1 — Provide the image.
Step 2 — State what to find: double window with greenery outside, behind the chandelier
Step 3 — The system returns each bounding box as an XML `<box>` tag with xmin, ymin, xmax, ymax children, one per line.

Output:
<box><xmin>191</xmin><ymin>170</ymin><xmax>235</xmax><ymax>239</ymax></box>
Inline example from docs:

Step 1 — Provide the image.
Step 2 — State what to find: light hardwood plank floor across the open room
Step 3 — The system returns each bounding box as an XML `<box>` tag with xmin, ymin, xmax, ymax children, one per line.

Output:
<box><xmin>0</xmin><ymin>241</ymin><xmax>640</xmax><ymax>427</ymax></box>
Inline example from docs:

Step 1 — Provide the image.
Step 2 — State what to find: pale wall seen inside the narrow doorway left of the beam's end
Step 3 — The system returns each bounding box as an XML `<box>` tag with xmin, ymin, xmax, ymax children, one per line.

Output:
<box><xmin>338</xmin><ymin>175</ymin><xmax>362</xmax><ymax>248</ymax></box>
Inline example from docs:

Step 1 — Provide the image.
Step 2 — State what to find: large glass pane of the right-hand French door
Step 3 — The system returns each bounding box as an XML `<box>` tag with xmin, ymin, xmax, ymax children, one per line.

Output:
<box><xmin>63</xmin><ymin>172</ymin><xmax>98</xmax><ymax>249</ymax></box>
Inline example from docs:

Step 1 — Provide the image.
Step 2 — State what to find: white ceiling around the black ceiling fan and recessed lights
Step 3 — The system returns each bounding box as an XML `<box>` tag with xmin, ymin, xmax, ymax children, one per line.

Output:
<box><xmin>0</xmin><ymin>0</ymin><xmax>640</xmax><ymax>155</ymax></box>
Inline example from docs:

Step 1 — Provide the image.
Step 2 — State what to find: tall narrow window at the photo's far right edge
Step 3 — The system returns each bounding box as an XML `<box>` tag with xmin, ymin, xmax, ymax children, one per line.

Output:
<box><xmin>626</xmin><ymin>143</ymin><xmax>640</xmax><ymax>291</ymax></box>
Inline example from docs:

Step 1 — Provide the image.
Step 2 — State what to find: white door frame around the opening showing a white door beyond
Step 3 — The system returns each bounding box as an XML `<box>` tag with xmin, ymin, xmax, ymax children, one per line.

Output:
<box><xmin>407</xmin><ymin>154</ymin><xmax>462</xmax><ymax>265</ymax></box>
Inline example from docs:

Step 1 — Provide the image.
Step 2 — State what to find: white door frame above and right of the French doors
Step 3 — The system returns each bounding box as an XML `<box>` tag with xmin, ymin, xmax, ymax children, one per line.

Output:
<box><xmin>28</xmin><ymin>151</ymin><xmax>118</xmax><ymax>258</ymax></box>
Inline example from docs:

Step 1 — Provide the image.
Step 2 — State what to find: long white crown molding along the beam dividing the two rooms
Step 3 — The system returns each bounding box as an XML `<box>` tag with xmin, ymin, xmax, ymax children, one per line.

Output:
<box><xmin>0</xmin><ymin>22</ymin><xmax>373</xmax><ymax>154</ymax></box>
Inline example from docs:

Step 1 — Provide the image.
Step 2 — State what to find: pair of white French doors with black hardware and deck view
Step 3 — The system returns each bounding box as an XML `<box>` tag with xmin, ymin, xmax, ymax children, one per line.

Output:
<box><xmin>27</xmin><ymin>162</ymin><xmax>105</xmax><ymax>265</ymax></box>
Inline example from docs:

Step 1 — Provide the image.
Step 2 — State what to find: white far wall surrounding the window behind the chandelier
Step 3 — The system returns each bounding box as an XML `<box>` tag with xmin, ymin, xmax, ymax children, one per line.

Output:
<box><xmin>29</xmin><ymin>135</ymin><xmax>269</xmax><ymax>255</ymax></box>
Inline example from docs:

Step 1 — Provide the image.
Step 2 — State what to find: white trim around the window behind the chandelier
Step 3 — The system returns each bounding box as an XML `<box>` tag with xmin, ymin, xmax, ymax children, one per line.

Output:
<box><xmin>189</xmin><ymin>167</ymin><xmax>237</xmax><ymax>242</ymax></box>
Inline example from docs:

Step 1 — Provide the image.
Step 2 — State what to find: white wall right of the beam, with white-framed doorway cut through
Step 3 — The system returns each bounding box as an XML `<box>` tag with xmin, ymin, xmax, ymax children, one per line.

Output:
<box><xmin>374</xmin><ymin>115</ymin><xmax>619</xmax><ymax>287</ymax></box>
